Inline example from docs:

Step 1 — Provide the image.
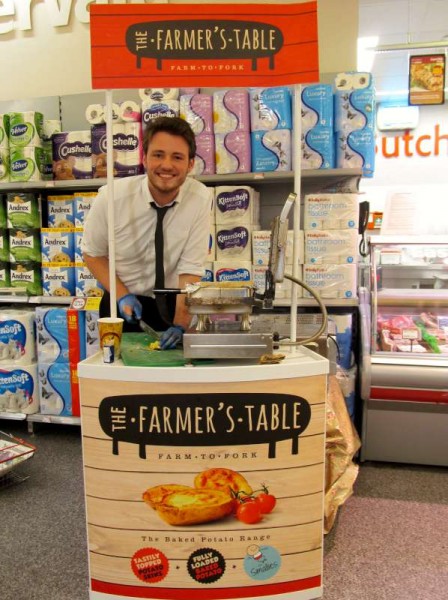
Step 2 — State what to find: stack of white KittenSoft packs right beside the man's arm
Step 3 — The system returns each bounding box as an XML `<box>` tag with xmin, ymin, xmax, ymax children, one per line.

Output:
<box><xmin>213</xmin><ymin>185</ymin><xmax>260</xmax><ymax>281</ymax></box>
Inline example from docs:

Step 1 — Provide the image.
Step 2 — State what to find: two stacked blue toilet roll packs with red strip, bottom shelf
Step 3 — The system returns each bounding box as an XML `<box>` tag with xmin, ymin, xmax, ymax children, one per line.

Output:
<box><xmin>36</xmin><ymin>306</ymin><xmax>86</xmax><ymax>416</ymax></box>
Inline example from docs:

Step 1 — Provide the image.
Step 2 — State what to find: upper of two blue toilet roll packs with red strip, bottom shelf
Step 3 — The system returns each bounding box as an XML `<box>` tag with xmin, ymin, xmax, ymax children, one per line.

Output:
<box><xmin>36</xmin><ymin>306</ymin><xmax>86</xmax><ymax>365</ymax></box>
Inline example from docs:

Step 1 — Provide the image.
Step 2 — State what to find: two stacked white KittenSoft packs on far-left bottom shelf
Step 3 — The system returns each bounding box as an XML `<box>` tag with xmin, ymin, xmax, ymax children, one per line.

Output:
<box><xmin>0</xmin><ymin>308</ymin><xmax>39</xmax><ymax>415</ymax></box>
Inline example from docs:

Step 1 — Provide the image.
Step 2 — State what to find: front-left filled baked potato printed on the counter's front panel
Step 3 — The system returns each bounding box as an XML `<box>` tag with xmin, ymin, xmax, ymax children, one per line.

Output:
<box><xmin>150</xmin><ymin>488</ymin><xmax>234</xmax><ymax>525</ymax></box>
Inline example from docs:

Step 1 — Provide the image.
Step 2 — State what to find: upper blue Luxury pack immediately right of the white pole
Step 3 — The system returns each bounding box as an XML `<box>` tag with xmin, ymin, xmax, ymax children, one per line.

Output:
<box><xmin>302</xmin><ymin>83</ymin><xmax>333</xmax><ymax>132</ymax></box>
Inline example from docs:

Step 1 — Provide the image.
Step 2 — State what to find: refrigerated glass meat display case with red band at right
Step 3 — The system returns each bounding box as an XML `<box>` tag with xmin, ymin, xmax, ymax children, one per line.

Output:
<box><xmin>360</xmin><ymin>236</ymin><xmax>448</xmax><ymax>465</ymax></box>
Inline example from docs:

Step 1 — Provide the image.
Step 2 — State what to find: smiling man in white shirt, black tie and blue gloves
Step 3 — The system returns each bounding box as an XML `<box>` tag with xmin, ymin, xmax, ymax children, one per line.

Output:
<box><xmin>82</xmin><ymin>117</ymin><xmax>212</xmax><ymax>349</ymax></box>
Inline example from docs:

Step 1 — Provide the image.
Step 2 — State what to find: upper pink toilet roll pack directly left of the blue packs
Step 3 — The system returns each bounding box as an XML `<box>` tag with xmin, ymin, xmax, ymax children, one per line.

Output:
<box><xmin>213</xmin><ymin>89</ymin><xmax>250</xmax><ymax>133</ymax></box>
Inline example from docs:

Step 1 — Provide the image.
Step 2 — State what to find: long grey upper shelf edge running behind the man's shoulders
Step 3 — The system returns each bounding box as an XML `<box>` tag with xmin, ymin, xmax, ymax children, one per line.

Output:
<box><xmin>0</xmin><ymin>169</ymin><xmax>362</xmax><ymax>192</ymax></box>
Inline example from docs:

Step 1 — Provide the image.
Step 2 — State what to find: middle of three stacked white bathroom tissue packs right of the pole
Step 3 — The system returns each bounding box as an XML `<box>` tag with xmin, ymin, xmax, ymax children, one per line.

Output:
<box><xmin>305</xmin><ymin>229</ymin><xmax>359</xmax><ymax>265</ymax></box>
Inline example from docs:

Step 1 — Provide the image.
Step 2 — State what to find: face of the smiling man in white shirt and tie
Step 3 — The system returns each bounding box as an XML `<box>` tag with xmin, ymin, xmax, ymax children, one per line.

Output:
<box><xmin>143</xmin><ymin>131</ymin><xmax>194</xmax><ymax>204</ymax></box>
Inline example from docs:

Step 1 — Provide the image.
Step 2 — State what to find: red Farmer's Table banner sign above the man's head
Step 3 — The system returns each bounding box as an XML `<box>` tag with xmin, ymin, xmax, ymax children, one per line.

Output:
<box><xmin>90</xmin><ymin>2</ymin><xmax>319</xmax><ymax>89</ymax></box>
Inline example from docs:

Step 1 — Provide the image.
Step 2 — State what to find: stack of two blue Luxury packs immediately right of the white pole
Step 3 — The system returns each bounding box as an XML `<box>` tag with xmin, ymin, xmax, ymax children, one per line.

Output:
<box><xmin>301</xmin><ymin>83</ymin><xmax>335</xmax><ymax>169</ymax></box>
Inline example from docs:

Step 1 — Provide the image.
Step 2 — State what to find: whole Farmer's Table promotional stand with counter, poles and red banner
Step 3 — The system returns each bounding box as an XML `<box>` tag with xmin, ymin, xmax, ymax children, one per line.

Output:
<box><xmin>78</xmin><ymin>2</ymin><xmax>328</xmax><ymax>600</ymax></box>
